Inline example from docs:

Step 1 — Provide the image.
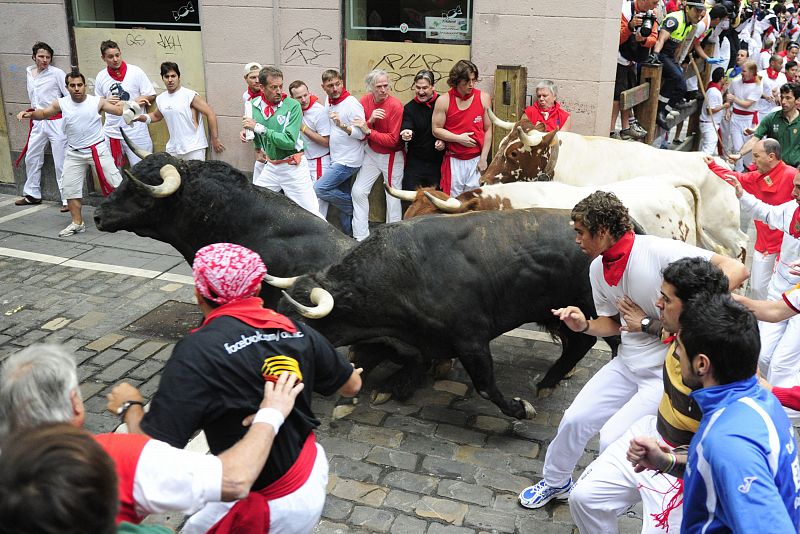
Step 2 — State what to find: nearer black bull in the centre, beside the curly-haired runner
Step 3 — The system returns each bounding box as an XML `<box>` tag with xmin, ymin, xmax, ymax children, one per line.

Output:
<box><xmin>279</xmin><ymin>209</ymin><xmax>596</xmax><ymax>418</ymax></box>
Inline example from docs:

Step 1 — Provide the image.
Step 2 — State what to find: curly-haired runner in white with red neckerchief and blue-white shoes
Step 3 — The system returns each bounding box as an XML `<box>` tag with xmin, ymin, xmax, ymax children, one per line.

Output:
<box><xmin>519</xmin><ymin>191</ymin><xmax>748</xmax><ymax>508</ymax></box>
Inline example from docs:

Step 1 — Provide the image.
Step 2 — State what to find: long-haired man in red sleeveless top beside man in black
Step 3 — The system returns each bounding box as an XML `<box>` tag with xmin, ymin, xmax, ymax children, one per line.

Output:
<box><xmin>431</xmin><ymin>59</ymin><xmax>492</xmax><ymax>197</ymax></box>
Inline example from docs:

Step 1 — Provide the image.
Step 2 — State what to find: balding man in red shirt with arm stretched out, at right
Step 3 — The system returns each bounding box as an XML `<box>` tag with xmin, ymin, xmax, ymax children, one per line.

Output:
<box><xmin>705</xmin><ymin>138</ymin><xmax>798</xmax><ymax>300</ymax></box>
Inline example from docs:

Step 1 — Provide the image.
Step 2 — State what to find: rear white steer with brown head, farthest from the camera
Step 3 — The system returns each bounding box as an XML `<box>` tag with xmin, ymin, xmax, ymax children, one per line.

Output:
<box><xmin>481</xmin><ymin>113</ymin><xmax>747</xmax><ymax>258</ymax></box>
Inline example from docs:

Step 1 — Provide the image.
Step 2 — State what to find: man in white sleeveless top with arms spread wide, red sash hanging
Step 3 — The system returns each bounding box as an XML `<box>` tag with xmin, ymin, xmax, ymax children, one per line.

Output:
<box><xmin>17</xmin><ymin>71</ymin><xmax>123</xmax><ymax>237</ymax></box>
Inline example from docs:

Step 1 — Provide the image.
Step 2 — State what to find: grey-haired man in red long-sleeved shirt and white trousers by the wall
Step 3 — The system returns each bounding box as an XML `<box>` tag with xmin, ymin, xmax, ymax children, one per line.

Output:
<box><xmin>351</xmin><ymin>69</ymin><xmax>405</xmax><ymax>241</ymax></box>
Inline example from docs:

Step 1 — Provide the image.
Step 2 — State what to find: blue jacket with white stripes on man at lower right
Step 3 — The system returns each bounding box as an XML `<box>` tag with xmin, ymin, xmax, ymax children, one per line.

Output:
<box><xmin>681</xmin><ymin>377</ymin><xmax>800</xmax><ymax>534</ymax></box>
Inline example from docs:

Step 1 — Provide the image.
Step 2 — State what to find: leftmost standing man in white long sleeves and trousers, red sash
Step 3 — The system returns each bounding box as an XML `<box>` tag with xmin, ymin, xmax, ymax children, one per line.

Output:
<box><xmin>15</xmin><ymin>42</ymin><xmax>69</xmax><ymax>212</ymax></box>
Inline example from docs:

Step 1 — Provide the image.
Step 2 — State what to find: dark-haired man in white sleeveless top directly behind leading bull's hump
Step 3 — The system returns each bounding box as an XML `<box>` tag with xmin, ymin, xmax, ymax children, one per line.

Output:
<box><xmin>126</xmin><ymin>61</ymin><xmax>225</xmax><ymax>161</ymax></box>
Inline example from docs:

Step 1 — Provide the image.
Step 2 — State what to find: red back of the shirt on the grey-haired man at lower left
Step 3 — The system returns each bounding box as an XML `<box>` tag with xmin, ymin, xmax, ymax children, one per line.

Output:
<box><xmin>94</xmin><ymin>434</ymin><xmax>150</xmax><ymax>524</ymax></box>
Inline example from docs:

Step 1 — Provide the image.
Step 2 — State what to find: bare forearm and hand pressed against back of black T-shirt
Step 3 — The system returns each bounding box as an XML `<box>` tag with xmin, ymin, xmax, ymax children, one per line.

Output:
<box><xmin>219</xmin><ymin>372</ymin><xmax>303</xmax><ymax>501</ymax></box>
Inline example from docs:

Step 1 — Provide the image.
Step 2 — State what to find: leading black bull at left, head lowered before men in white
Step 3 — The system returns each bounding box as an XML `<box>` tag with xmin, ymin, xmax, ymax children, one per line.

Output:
<box><xmin>94</xmin><ymin>153</ymin><xmax>356</xmax><ymax>307</ymax></box>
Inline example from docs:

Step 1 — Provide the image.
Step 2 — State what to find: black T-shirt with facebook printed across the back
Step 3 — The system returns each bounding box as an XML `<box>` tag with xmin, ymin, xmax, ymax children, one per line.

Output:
<box><xmin>142</xmin><ymin>316</ymin><xmax>353</xmax><ymax>490</ymax></box>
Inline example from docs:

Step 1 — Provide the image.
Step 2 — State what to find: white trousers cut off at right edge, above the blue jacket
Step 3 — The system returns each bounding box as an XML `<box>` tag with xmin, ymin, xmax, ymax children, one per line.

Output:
<box><xmin>758</xmin><ymin>315</ymin><xmax>800</xmax><ymax>425</ymax></box>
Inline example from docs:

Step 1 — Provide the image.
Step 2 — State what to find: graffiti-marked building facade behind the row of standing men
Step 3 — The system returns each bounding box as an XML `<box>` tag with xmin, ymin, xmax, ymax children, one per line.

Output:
<box><xmin>0</xmin><ymin>0</ymin><xmax>620</xmax><ymax>198</ymax></box>
